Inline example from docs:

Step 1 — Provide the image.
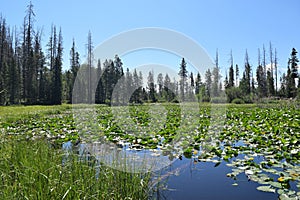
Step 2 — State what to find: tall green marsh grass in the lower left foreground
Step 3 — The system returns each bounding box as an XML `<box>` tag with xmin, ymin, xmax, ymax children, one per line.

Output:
<box><xmin>0</xmin><ymin>138</ymin><xmax>150</xmax><ymax>199</ymax></box>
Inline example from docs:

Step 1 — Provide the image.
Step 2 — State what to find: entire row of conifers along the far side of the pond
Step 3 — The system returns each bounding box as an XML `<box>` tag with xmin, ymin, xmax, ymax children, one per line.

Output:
<box><xmin>0</xmin><ymin>3</ymin><xmax>300</xmax><ymax>105</ymax></box>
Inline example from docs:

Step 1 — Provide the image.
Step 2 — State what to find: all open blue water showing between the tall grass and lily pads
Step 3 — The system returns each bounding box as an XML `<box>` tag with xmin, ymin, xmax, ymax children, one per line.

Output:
<box><xmin>63</xmin><ymin>141</ymin><xmax>297</xmax><ymax>200</ymax></box>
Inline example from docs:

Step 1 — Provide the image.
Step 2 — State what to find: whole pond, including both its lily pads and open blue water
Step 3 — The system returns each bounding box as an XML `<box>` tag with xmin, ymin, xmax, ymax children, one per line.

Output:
<box><xmin>0</xmin><ymin>103</ymin><xmax>300</xmax><ymax>200</ymax></box>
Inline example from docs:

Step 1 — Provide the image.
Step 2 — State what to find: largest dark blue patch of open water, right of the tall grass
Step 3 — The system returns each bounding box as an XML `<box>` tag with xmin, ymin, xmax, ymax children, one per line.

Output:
<box><xmin>156</xmin><ymin>158</ymin><xmax>278</xmax><ymax>200</ymax></box>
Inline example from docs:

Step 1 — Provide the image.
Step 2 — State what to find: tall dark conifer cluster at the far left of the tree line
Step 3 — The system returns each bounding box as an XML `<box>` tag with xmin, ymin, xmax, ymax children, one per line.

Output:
<box><xmin>0</xmin><ymin>3</ymin><xmax>63</xmax><ymax>105</ymax></box>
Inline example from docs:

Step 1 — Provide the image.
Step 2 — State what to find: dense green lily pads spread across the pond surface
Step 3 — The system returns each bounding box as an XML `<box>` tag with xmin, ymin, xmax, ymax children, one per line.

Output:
<box><xmin>0</xmin><ymin>103</ymin><xmax>300</xmax><ymax>199</ymax></box>
